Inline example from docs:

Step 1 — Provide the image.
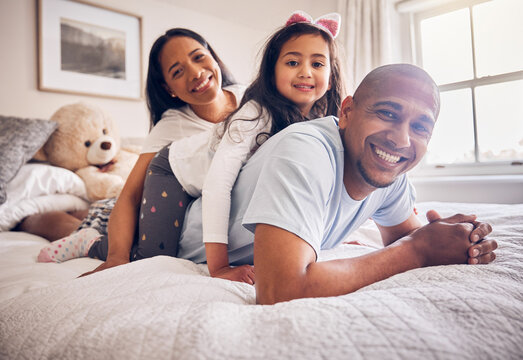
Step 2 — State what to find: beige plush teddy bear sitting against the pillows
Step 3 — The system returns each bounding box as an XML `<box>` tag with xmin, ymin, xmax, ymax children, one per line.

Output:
<box><xmin>34</xmin><ymin>102</ymin><xmax>138</xmax><ymax>201</ymax></box>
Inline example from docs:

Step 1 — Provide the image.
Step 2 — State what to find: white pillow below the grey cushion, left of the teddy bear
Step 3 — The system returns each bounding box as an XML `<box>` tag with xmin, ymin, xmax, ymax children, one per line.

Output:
<box><xmin>0</xmin><ymin>163</ymin><xmax>89</xmax><ymax>231</ymax></box>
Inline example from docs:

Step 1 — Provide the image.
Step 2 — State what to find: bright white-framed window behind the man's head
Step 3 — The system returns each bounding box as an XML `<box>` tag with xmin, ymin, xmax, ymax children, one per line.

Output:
<box><xmin>411</xmin><ymin>0</ymin><xmax>523</xmax><ymax>175</ymax></box>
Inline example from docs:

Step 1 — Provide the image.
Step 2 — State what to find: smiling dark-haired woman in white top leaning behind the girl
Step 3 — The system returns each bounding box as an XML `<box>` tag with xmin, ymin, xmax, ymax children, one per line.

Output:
<box><xmin>33</xmin><ymin>28</ymin><xmax>244</xmax><ymax>274</ymax></box>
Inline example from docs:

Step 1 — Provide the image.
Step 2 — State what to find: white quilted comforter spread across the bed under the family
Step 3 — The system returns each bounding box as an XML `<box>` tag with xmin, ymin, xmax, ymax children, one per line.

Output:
<box><xmin>0</xmin><ymin>203</ymin><xmax>523</xmax><ymax>359</ymax></box>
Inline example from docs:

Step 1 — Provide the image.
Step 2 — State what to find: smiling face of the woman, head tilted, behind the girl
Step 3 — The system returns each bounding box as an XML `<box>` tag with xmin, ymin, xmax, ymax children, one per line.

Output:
<box><xmin>159</xmin><ymin>36</ymin><xmax>222</xmax><ymax>105</ymax></box>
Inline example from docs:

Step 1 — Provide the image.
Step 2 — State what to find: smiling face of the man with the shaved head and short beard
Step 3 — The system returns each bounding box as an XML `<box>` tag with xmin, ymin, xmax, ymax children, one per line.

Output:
<box><xmin>339</xmin><ymin>73</ymin><xmax>439</xmax><ymax>199</ymax></box>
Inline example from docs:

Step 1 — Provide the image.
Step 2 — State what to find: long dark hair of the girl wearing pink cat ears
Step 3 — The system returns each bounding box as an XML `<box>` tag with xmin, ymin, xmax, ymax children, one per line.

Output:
<box><xmin>226</xmin><ymin>23</ymin><xmax>344</xmax><ymax>139</ymax></box>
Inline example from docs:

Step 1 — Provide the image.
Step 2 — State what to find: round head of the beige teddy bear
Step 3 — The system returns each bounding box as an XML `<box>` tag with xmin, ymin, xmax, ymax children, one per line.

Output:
<box><xmin>44</xmin><ymin>103</ymin><xmax>120</xmax><ymax>171</ymax></box>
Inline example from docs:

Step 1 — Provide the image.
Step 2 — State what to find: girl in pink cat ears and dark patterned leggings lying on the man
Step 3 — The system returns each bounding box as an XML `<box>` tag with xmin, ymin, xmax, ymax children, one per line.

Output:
<box><xmin>39</xmin><ymin>12</ymin><xmax>342</xmax><ymax>284</ymax></box>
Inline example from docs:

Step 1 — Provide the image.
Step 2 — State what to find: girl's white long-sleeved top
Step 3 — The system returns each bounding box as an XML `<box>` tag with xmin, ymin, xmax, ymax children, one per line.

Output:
<box><xmin>169</xmin><ymin>101</ymin><xmax>272</xmax><ymax>244</ymax></box>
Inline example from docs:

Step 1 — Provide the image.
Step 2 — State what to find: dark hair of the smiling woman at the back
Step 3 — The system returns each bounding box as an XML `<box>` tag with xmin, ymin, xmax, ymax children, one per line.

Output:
<box><xmin>145</xmin><ymin>28</ymin><xmax>236</xmax><ymax>127</ymax></box>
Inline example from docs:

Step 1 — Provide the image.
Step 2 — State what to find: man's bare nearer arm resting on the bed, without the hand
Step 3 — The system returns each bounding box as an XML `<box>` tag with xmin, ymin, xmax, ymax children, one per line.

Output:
<box><xmin>254</xmin><ymin>224</ymin><xmax>420</xmax><ymax>304</ymax></box>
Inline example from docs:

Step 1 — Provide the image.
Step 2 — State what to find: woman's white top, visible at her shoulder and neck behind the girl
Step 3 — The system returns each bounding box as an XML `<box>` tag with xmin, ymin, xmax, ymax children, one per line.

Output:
<box><xmin>141</xmin><ymin>85</ymin><xmax>245</xmax><ymax>154</ymax></box>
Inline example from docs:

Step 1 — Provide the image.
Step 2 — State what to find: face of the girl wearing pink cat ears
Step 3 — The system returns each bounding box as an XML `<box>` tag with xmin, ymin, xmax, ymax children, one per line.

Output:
<box><xmin>274</xmin><ymin>34</ymin><xmax>331</xmax><ymax>116</ymax></box>
